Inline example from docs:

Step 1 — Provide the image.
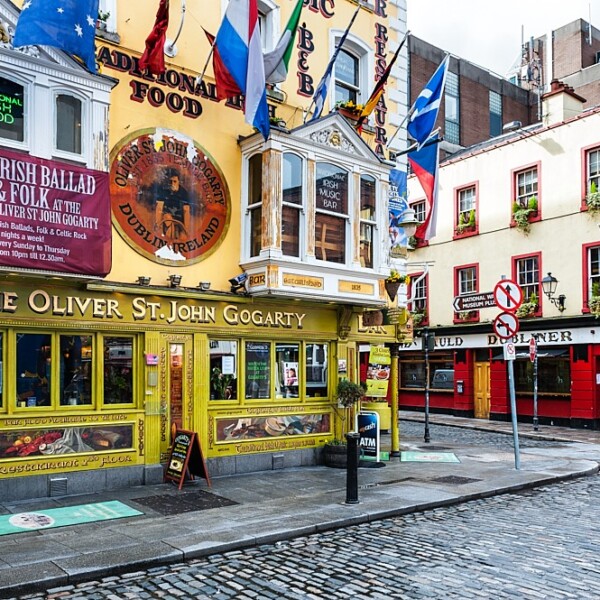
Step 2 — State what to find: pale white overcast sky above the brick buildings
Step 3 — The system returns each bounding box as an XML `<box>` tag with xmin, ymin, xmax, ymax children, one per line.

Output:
<box><xmin>407</xmin><ymin>0</ymin><xmax>600</xmax><ymax>76</ymax></box>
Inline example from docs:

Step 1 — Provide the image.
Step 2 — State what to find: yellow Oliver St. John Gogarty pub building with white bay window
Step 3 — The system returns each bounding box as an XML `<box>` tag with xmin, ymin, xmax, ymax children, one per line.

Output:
<box><xmin>0</xmin><ymin>0</ymin><xmax>410</xmax><ymax>499</ymax></box>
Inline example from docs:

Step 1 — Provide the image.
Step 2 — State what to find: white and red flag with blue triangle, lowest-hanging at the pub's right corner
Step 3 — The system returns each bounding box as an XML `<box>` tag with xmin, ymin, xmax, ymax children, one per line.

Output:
<box><xmin>408</xmin><ymin>133</ymin><xmax>440</xmax><ymax>241</ymax></box>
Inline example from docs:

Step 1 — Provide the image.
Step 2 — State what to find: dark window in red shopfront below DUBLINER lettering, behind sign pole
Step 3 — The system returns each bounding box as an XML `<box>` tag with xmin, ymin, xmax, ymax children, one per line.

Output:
<box><xmin>515</xmin><ymin>348</ymin><xmax>571</xmax><ymax>396</ymax></box>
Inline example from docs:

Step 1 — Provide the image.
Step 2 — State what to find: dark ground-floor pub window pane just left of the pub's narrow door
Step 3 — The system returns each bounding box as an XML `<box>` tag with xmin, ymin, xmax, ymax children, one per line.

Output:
<box><xmin>103</xmin><ymin>336</ymin><xmax>134</xmax><ymax>404</ymax></box>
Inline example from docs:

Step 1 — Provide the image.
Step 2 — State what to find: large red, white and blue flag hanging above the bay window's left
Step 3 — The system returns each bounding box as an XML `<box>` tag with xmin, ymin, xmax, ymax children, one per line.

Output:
<box><xmin>215</xmin><ymin>0</ymin><xmax>270</xmax><ymax>139</ymax></box>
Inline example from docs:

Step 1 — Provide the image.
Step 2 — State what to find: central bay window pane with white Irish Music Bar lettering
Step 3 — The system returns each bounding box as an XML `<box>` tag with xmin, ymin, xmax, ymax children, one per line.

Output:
<box><xmin>315</xmin><ymin>163</ymin><xmax>349</xmax><ymax>263</ymax></box>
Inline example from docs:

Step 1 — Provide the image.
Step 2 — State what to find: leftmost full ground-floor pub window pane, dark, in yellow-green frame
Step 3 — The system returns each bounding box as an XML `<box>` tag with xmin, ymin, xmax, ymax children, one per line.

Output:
<box><xmin>16</xmin><ymin>333</ymin><xmax>52</xmax><ymax>408</ymax></box>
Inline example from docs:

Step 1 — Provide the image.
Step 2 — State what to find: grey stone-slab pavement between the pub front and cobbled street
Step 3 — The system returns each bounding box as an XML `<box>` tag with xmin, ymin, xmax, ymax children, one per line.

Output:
<box><xmin>0</xmin><ymin>411</ymin><xmax>600</xmax><ymax>597</ymax></box>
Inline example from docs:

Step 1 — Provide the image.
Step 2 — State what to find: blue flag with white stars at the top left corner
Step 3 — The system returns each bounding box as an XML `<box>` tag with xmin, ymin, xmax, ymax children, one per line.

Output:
<box><xmin>13</xmin><ymin>0</ymin><xmax>99</xmax><ymax>73</ymax></box>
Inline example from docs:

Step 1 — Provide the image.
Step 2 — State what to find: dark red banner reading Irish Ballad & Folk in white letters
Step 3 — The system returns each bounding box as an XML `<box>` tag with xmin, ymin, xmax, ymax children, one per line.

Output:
<box><xmin>0</xmin><ymin>149</ymin><xmax>112</xmax><ymax>276</ymax></box>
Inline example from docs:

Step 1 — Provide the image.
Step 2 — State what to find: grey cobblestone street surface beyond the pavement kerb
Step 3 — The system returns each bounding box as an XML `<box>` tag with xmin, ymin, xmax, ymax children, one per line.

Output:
<box><xmin>10</xmin><ymin>423</ymin><xmax>600</xmax><ymax>600</ymax></box>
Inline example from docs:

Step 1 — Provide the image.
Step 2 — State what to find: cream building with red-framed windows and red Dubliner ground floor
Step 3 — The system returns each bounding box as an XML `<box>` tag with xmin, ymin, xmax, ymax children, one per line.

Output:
<box><xmin>400</xmin><ymin>82</ymin><xmax>600</xmax><ymax>427</ymax></box>
